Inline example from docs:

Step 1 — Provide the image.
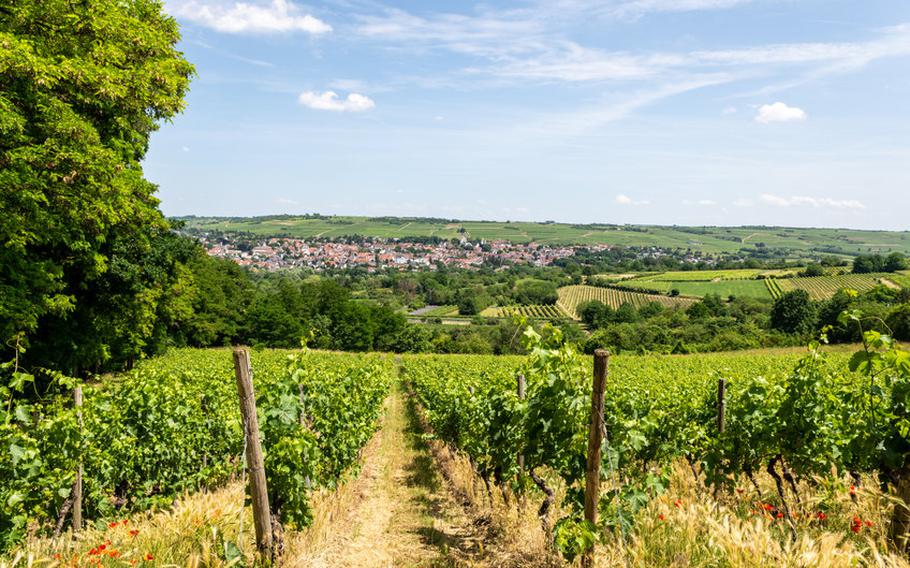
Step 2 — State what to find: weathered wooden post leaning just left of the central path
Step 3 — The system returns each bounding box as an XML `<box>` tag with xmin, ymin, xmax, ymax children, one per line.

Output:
<box><xmin>234</xmin><ymin>347</ymin><xmax>272</xmax><ymax>553</ymax></box>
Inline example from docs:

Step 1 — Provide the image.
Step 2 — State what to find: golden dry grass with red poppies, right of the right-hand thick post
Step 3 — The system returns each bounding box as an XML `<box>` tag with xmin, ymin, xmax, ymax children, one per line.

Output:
<box><xmin>596</xmin><ymin>466</ymin><xmax>910</xmax><ymax>568</ymax></box>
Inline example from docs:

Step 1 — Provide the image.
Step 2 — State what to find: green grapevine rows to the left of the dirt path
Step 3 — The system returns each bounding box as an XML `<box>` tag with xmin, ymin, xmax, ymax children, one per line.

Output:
<box><xmin>0</xmin><ymin>350</ymin><xmax>392</xmax><ymax>549</ymax></box>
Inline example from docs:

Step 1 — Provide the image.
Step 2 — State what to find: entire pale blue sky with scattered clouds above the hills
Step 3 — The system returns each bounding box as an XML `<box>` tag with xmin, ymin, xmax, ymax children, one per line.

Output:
<box><xmin>145</xmin><ymin>0</ymin><xmax>910</xmax><ymax>229</ymax></box>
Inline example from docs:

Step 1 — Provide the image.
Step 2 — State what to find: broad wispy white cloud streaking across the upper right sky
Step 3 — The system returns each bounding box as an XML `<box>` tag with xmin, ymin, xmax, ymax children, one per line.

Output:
<box><xmin>355</xmin><ymin>5</ymin><xmax>910</xmax><ymax>87</ymax></box>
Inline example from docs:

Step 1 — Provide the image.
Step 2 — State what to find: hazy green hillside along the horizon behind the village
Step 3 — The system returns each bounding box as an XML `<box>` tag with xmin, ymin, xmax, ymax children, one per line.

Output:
<box><xmin>176</xmin><ymin>215</ymin><xmax>910</xmax><ymax>257</ymax></box>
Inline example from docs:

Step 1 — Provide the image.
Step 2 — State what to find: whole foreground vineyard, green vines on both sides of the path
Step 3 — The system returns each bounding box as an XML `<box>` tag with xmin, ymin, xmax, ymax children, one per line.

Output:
<box><xmin>8</xmin><ymin>336</ymin><xmax>910</xmax><ymax>565</ymax></box>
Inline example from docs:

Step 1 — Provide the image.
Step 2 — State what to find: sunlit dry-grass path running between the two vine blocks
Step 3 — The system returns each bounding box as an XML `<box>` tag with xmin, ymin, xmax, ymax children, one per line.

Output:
<box><xmin>290</xmin><ymin>385</ymin><xmax>483</xmax><ymax>568</ymax></box>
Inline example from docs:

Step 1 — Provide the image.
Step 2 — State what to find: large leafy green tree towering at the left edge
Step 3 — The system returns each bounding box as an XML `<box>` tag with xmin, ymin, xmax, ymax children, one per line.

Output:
<box><xmin>0</xmin><ymin>0</ymin><xmax>193</xmax><ymax>378</ymax></box>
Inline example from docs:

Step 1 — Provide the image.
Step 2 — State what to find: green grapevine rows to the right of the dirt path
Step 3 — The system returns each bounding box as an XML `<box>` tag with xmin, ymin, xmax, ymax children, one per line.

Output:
<box><xmin>403</xmin><ymin>326</ymin><xmax>910</xmax><ymax>559</ymax></box>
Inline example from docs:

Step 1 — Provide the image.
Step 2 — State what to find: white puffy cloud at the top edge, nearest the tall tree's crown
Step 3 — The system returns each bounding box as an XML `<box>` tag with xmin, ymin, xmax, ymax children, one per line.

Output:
<box><xmin>167</xmin><ymin>0</ymin><xmax>332</xmax><ymax>34</ymax></box>
